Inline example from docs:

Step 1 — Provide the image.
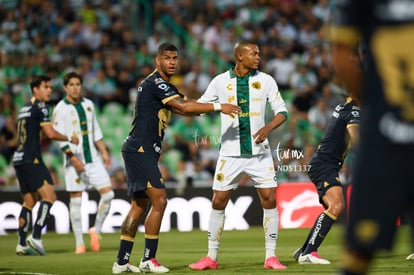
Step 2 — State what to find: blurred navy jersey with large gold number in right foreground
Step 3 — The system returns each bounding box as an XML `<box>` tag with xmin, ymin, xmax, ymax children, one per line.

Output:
<box><xmin>330</xmin><ymin>0</ymin><xmax>414</xmax><ymax>144</ymax></box>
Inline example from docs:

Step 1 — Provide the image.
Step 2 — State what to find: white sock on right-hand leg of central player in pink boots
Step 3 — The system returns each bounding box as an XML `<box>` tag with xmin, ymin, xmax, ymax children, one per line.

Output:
<box><xmin>263</xmin><ymin>208</ymin><xmax>279</xmax><ymax>259</ymax></box>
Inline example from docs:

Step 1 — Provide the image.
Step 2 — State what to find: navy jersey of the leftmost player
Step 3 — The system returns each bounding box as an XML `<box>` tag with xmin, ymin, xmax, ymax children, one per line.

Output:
<box><xmin>13</xmin><ymin>98</ymin><xmax>51</xmax><ymax>166</ymax></box>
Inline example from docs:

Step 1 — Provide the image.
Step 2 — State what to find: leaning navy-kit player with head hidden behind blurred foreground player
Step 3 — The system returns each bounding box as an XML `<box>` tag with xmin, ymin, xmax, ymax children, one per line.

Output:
<box><xmin>293</xmin><ymin>97</ymin><xmax>360</xmax><ymax>264</ymax></box>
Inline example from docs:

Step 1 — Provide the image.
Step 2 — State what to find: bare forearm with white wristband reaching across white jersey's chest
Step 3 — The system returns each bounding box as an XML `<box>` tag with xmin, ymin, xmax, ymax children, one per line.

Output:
<box><xmin>166</xmin><ymin>97</ymin><xmax>240</xmax><ymax>116</ymax></box>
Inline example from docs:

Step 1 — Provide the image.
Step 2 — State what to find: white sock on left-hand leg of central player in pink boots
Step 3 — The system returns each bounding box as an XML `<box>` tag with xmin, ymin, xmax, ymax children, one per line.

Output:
<box><xmin>207</xmin><ymin>209</ymin><xmax>224</xmax><ymax>261</ymax></box>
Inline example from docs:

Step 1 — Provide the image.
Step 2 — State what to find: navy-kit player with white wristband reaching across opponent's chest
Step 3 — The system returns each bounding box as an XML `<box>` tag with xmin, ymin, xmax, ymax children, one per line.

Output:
<box><xmin>112</xmin><ymin>43</ymin><xmax>240</xmax><ymax>274</ymax></box>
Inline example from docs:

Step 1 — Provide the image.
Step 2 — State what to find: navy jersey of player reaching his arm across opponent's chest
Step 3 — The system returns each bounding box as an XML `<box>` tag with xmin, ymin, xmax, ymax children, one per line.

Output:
<box><xmin>122</xmin><ymin>71</ymin><xmax>182</xmax><ymax>152</ymax></box>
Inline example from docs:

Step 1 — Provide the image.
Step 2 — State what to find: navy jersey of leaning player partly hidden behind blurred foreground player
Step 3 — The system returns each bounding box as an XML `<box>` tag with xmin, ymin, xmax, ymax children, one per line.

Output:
<box><xmin>316</xmin><ymin>98</ymin><xmax>360</xmax><ymax>166</ymax></box>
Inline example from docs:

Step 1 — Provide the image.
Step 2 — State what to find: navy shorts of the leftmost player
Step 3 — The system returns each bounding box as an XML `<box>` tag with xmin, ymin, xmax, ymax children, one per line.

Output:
<box><xmin>14</xmin><ymin>162</ymin><xmax>53</xmax><ymax>195</ymax></box>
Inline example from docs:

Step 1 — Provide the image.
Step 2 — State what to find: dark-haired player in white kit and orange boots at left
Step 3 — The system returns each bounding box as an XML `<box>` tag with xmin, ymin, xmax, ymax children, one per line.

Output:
<box><xmin>53</xmin><ymin>72</ymin><xmax>114</xmax><ymax>254</ymax></box>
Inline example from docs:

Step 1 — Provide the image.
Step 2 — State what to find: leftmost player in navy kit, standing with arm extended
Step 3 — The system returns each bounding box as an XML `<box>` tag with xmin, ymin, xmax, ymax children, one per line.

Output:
<box><xmin>13</xmin><ymin>75</ymin><xmax>78</xmax><ymax>255</ymax></box>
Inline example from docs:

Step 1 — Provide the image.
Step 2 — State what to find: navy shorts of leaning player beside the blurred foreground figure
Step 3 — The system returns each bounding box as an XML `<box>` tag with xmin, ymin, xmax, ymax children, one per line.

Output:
<box><xmin>308</xmin><ymin>157</ymin><xmax>342</xmax><ymax>204</ymax></box>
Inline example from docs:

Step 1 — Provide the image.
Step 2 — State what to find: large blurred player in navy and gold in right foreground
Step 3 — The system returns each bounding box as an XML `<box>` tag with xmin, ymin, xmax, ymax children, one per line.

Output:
<box><xmin>329</xmin><ymin>0</ymin><xmax>414</xmax><ymax>275</ymax></box>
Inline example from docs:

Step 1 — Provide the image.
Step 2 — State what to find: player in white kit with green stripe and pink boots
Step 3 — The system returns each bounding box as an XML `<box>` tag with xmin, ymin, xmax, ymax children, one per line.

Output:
<box><xmin>189</xmin><ymin>41</ymin><xmax>287</xmax><ymax>270</ymax></box>
